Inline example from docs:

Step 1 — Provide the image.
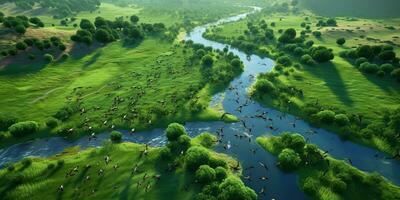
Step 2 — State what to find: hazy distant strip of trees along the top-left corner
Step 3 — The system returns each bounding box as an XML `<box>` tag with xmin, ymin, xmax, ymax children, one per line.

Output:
<box><xmin>0</xmin><ymin>0</ymin><xmax>101</xmax><ymax>18</ymax></box>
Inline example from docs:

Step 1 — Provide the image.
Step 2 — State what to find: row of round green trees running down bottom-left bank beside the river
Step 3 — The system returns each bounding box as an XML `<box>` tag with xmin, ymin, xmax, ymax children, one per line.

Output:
<box><xmin>160</xmin><ymin>123</ymin><xmax>257</xmax><ymax>200</ymax></box>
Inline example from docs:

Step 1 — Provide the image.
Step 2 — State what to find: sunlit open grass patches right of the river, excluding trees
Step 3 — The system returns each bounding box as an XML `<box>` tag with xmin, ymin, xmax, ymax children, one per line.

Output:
<box><xmin>206</xmin><ymin>13</ymin><xmax>400</xmax><ymax>118</ymax></box>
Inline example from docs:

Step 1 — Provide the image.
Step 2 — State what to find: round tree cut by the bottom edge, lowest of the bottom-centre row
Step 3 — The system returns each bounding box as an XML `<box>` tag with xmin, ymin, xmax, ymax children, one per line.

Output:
<box><xmin>218</xmin><ymin>177</ymin><xmax>257</xmax><ymax>200</ymax></box>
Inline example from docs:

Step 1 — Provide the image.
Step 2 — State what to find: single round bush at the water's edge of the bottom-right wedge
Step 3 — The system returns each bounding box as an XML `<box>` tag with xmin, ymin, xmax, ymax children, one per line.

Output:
<box><xmin>278</xmin><ymin>148</ymin><xmax>301</xmax><ymax>171</ymax></box>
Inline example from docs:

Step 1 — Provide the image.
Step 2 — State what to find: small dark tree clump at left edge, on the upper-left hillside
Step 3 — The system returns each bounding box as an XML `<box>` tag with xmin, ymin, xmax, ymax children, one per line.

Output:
<box><xmin>0</xmin><ymin>12</ymin><xmax>44</xmax><ymax>34</ymax></box>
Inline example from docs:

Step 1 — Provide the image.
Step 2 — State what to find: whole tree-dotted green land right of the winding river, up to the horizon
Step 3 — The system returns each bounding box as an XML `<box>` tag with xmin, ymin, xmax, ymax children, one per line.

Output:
<box><xmin>205</xmin><ymin>4</ymin><xmax>400</xmax><ymax>153</ymax></box>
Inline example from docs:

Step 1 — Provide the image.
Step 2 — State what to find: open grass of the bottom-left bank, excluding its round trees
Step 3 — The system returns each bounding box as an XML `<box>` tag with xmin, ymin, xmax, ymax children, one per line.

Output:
<box><xmin>0</xmin><ymin>134</ymin><xmax>244</xmax><ymax>199</ymax></box>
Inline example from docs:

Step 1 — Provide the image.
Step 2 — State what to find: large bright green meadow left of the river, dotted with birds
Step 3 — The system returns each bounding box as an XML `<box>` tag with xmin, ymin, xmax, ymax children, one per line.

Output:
<box><xmin>0</xmin><ymin>36</ymin><xmax>241</xmax><ymax>146</ymax></box>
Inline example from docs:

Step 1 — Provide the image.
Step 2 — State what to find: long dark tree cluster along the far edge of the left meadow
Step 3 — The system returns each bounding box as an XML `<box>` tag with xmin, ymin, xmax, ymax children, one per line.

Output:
<box><xmin>71</xmin><ymin>15</ymin><xmax>167</xmax><ymax>45</ymax></box>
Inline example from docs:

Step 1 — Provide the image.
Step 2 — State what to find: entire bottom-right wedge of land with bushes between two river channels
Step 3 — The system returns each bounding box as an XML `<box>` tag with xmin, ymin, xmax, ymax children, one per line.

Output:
<box><xmin>257</xmin><ymin>133</ymin><xmax>400</xmax><ymax>200</ymax></box>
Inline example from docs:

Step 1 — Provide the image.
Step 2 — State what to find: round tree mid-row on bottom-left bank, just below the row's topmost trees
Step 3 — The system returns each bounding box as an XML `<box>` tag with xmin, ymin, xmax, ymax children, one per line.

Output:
<box><xmin>185</xmin><ymin>146</ymin><xmax>210</xmax><ymax>172</ymax></box>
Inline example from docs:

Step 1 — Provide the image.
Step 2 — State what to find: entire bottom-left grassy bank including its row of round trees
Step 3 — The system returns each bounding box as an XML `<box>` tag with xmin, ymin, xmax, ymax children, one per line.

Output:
<box><xmin>0</xmin><ymin>124</ymin><xmax>257</xmax><ymax>200</ymax></box>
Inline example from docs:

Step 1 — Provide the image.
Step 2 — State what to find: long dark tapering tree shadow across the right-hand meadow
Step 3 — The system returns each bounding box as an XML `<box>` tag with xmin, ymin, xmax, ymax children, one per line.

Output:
<box><xmin>305</xmin><ymin>62</ymin><xmax>353</xmax><ymax>106</ymax></box>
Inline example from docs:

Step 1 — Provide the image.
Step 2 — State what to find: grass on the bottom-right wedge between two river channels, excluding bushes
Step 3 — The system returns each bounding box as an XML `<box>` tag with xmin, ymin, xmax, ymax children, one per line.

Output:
<box><xmin>257</xmin><ymin>136</ymin><xmax>400</xmax><ymax>200</ymax></box>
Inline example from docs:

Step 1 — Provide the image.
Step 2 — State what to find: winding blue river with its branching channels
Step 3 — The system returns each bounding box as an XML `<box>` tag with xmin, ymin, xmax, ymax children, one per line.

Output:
<box><xmin>0</xmin><ymin>8</ymin><xmax>400</xmax><ymax>199</ymax></box>
